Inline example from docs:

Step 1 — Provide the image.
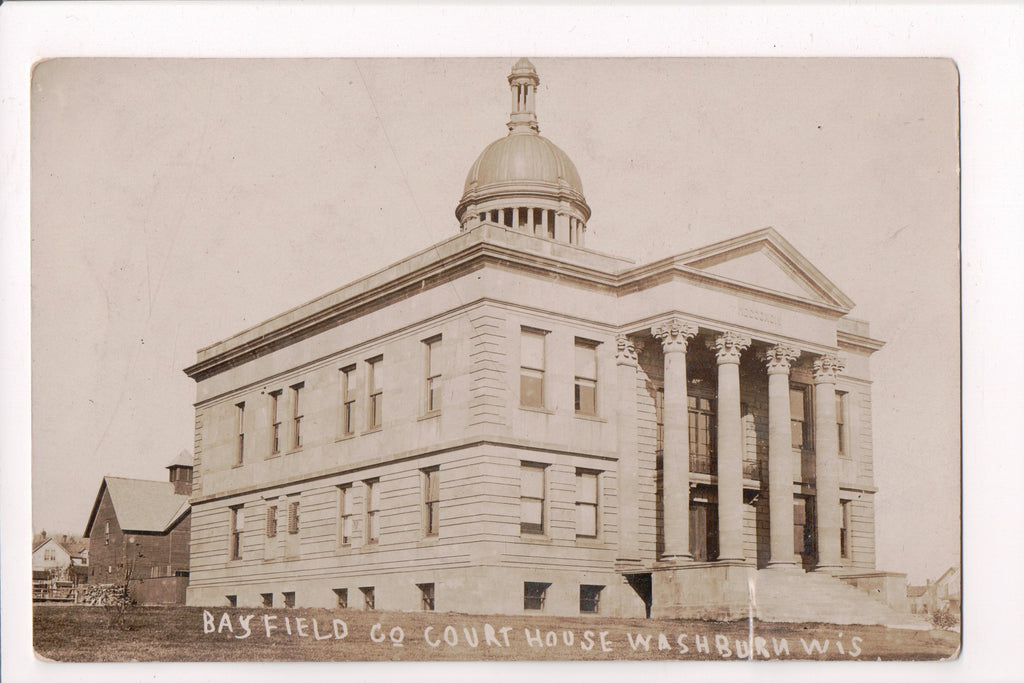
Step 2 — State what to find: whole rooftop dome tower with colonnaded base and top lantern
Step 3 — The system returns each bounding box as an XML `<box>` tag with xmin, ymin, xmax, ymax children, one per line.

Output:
<box><xmin>455</xmin><ymin>58</ymin><xmax>590</xmax><ymax>247</ymax></box>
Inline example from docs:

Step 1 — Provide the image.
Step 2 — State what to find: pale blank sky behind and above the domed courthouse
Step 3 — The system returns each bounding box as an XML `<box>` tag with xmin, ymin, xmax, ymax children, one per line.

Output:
<box><xmin>32</xmin><ymin>54</ymin><xmax>961</xmax><ymax>583</ymax></box>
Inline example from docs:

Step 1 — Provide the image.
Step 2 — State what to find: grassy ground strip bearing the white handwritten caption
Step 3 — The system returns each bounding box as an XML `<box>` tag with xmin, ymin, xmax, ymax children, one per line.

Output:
<box><xmin>33</xmin><ymin>604</ymin><xmax>959</xmax><ymax>661</ymax></box>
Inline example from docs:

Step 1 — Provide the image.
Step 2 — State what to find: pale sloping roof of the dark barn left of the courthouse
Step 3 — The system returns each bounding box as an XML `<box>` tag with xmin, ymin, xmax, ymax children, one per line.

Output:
<box><xmin>85</xmin><ymin>476</ymin><xmax>188</xmax><ymax>536</ymax></box>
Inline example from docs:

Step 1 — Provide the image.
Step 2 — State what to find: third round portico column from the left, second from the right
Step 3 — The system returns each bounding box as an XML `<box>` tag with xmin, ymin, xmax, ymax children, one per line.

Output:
<box><xmin>765</xmin><ymin>344</ymin><xmax>800</xmax><ymax>568</ymax></box>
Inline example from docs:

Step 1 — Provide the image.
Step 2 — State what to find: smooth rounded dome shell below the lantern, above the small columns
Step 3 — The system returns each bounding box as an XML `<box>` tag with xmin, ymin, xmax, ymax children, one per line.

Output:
<box><xmin>464</xmin><ymin>133</ymin><xmax>583</xmax><ymax>195</ymax></box>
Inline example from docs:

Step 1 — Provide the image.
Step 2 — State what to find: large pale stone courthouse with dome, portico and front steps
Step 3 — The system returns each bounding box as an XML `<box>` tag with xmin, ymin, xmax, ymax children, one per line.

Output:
<box><xmin>185</xmin><ymin>59</ymin><xmax>905</xmax><ymax>623</ymax></box>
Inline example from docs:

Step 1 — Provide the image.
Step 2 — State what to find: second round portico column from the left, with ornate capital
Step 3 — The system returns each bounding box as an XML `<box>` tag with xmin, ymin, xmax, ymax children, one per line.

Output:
<box><xmin>715</xmin><ymin>332</ymin><xmax>751</xmax><ymax>560</ymax></box>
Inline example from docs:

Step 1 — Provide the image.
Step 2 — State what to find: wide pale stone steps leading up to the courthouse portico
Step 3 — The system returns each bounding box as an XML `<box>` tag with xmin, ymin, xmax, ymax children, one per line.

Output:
<box><xmin>751</xmin><ymin>569</ymin><xmax>932</xmax><ymax>630</ymax></box>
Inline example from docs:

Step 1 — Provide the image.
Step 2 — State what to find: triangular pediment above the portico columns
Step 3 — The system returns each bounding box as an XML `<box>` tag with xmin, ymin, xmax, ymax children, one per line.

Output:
<box><xmin>676</xmin><ymin>227</ymin><xmax>854</xmax><ymax>310</ymax></box>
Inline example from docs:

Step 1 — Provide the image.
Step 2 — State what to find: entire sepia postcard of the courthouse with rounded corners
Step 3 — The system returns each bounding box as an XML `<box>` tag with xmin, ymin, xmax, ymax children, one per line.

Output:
<box><xmin>8</xmin><ymin>2</ymin><xmax>1019</xmax><ymax>678</ymax></box>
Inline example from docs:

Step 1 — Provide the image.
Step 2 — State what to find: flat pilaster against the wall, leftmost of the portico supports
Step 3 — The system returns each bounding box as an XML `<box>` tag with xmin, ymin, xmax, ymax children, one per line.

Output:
<box><xmin>615</xmin><ymin>336</ymin><xmax>640</xmax><ymax>564</ymax></box>
